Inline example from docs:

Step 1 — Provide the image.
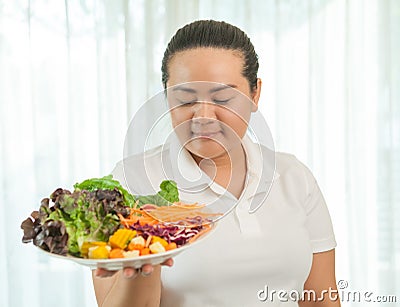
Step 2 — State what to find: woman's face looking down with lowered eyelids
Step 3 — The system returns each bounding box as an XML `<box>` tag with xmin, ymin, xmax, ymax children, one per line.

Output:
<box><xmin>167</xmin><ymin>48</ymin><xmax>261</xmax><ymax>159</ymax></box>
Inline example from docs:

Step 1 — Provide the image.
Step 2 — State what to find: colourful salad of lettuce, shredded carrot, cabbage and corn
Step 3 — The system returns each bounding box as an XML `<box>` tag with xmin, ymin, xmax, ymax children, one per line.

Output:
<box><xmin>21</xmin><ymin>175</ymin><xmax>219</xmax><ymax>259</ymax></box>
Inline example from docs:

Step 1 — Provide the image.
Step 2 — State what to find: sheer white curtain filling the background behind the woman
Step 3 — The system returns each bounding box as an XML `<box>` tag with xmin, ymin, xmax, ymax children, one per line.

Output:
<box><xmin>0</xmin><ymin>0</ymin><xmax>400</xmax><ymax>307</ymax></box>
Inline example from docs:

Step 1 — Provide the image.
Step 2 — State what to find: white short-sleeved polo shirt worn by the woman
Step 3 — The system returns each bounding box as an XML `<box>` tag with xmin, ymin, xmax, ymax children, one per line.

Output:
<box><xmin>113</xmin><ymin>137</ymin><xmax>336</xmax><ymax>307</ymax></box>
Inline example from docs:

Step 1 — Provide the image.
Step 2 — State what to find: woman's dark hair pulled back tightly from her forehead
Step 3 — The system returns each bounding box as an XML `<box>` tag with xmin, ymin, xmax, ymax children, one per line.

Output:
<box><xmin>161</xmin><ymin>20</ymin><xmax>258</xmax><ymax>90</ymax></box>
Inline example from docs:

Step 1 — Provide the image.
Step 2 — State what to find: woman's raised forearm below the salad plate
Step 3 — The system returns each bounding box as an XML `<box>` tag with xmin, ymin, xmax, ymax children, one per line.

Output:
<box><xmin>93</xmin><ymin>266</ymin><xmax>161</xmax><ymax>307</ymax></box>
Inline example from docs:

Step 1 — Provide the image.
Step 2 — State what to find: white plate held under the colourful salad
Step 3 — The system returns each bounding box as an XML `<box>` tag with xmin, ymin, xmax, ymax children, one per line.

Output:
<box><xmin>39</xmin><ymin>224</ymin><xmax>216</xmax><ymax>271</ymax></box>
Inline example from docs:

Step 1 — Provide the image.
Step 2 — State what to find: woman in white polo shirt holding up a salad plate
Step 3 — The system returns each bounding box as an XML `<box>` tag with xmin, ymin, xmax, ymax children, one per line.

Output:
<box><xmin>93</xmin><ymin>21</ymin><xmax>340</xmax><ymax>307</ymax></box>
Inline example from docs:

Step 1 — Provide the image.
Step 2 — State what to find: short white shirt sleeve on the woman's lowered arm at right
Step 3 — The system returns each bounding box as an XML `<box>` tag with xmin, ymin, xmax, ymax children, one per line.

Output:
<box><xmin>304</xmin><ymin>164</ymin><xmax>336</xmax><ymax>253</ymax></box>
